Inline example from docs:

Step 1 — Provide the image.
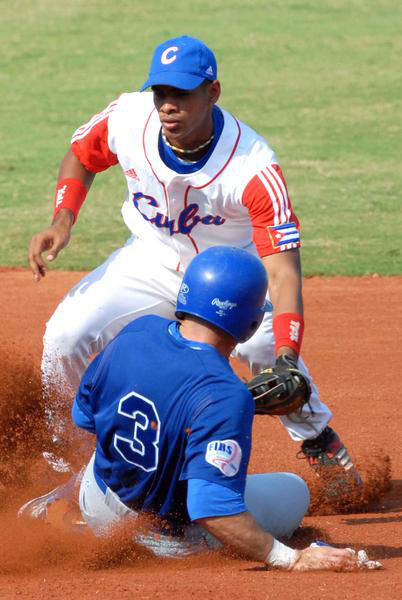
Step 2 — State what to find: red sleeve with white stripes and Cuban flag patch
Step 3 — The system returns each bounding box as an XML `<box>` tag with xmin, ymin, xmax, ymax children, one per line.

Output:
<box><xmin>242</xmin><ymin>164</ymin><xmax>300</xmax><ymax>258</ymax></box>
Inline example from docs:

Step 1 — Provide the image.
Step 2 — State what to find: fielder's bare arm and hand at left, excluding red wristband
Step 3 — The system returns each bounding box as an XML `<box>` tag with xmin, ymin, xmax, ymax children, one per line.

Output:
<box><xmin>28</xmin><ymin>150</ymin><xmax>95</xmax><ymax>281</ymax></box>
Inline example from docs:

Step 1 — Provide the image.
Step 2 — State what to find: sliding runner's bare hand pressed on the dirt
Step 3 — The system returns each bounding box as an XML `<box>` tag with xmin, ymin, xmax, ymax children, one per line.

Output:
<box><xmin>291</xmin><ymin>546</ymin><xmax>359</xmax><ymax>571</ymax></box>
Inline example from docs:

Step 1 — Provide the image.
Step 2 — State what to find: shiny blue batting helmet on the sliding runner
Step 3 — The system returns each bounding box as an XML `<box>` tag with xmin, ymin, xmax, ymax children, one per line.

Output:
<box><xmin>176</xmin><ymin>246</ymin><xmax>272</xmax><ymax>342</ymax></box>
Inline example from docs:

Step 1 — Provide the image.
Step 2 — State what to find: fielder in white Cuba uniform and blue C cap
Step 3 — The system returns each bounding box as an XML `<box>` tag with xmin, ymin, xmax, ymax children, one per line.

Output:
<box><xmin>29</xmin><ymin>36</ymin><xmax>354</xmax><ymax>472</ymax></box>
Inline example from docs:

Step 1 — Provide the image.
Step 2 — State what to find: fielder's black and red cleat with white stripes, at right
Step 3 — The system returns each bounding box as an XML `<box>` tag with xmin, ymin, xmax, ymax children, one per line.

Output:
<box><xmin>298</xmin><ymin>426</ymin><xmax>362</xmax><ymax>485</ymax></box>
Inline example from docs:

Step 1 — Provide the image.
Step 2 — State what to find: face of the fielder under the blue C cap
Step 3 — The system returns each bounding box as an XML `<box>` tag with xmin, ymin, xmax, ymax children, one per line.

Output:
<box><xmin>152</xmin><ymin>81</ymin><xmax>220</xmax><ymax>149</ymax></box>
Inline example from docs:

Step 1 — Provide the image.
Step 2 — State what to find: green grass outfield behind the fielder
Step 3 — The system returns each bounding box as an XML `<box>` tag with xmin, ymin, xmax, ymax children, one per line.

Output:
<box><xmin>0</xmin><ymin>0</ymin><xmax>402</xmax><ymax>275</ymax></box>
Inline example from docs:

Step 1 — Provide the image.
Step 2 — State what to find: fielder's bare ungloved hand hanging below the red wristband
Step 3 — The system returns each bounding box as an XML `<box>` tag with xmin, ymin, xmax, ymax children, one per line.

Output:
<box><xmin>28</xmin><ymin>210</ymin><xmax>72</xmax><ymax>281</ymax></box>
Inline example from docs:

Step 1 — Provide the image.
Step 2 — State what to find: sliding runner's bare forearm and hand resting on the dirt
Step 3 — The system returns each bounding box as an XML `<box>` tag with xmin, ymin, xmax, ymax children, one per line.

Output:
<box><xmin>198</xmin><ymin>512</ymin><xmax>358</xmax><ymax>571</ymax></box>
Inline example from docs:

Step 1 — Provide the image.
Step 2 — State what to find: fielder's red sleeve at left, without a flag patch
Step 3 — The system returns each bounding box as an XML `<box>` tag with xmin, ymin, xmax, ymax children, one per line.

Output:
<box><xmin>71</xmin><ymin>102</ymin><xmax>118</xmax><ymax>173</ymax></box>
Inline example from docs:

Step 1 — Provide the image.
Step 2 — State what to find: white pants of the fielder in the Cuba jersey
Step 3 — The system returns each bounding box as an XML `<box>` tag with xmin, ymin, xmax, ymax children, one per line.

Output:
<box><xmin>42</xmin><ymin>237</ymin><xmax>332</xmax><ymax>440</ymax></box>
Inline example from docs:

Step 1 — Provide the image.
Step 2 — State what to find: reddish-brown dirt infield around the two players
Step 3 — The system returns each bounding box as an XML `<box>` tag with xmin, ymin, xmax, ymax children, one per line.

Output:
<box><xmin>0</xmin><ymin>270</ymin><xmax>402</xmax><ymax>600</ymax></box>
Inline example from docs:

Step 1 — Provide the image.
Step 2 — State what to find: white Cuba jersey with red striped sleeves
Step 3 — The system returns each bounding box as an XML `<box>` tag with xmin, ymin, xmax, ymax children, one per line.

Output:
<box><xmin>72</xmin><ymin>92</ymin><xmax>300</xmax><ymax>271</ymax></box>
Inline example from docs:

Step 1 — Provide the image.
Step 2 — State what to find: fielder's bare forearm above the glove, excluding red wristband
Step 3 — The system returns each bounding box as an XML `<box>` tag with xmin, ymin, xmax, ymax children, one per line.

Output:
<box><xmin>262</xmin><ymin>249</ymin><xmax>303</xmax><ymax>358</ymax></box>
